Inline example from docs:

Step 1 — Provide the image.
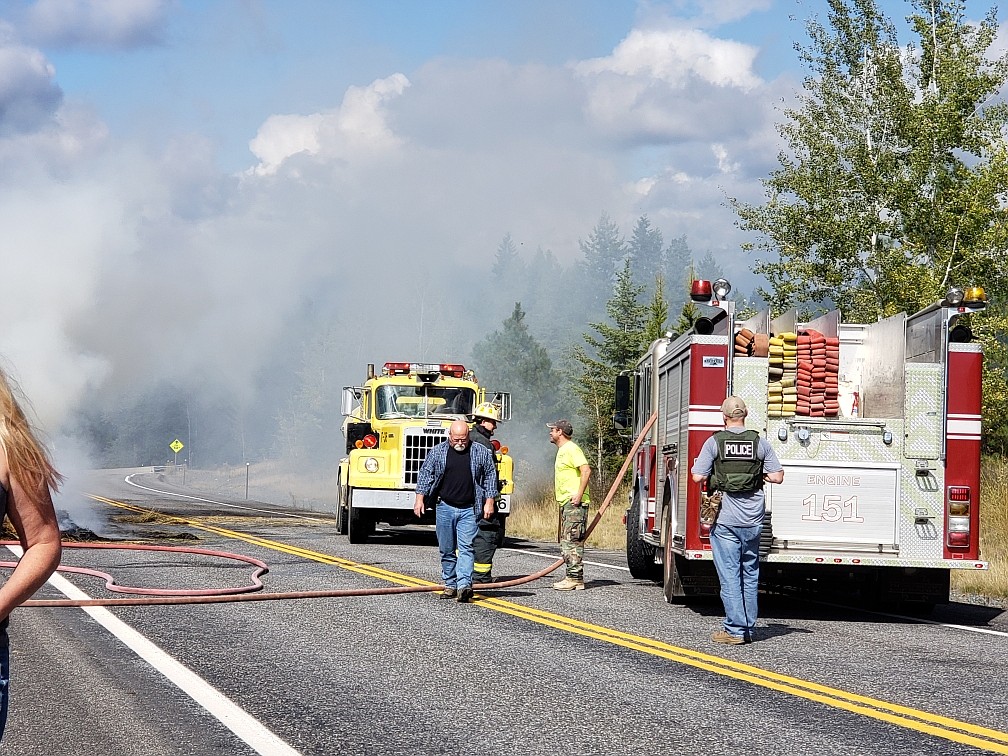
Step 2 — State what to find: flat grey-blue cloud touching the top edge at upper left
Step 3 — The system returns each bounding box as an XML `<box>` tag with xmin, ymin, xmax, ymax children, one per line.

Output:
<box><xmin>20</xmin><ymin>0</ymin><xmax>169</xmax><ymax>49</ymax></box>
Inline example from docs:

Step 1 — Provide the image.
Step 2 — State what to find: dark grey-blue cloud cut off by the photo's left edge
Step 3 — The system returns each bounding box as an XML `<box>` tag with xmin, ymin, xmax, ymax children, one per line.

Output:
<box><xmin>0</xmin><ymin>27</ymin><xmax>62</xmax><ymax>138</ymax></box>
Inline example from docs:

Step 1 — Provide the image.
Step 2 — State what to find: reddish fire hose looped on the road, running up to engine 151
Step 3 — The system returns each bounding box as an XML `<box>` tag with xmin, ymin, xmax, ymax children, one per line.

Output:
<box><xmin>11</xmin><ymin>413</ymin><xmax>657</xmax><ymax>607</ymax></box>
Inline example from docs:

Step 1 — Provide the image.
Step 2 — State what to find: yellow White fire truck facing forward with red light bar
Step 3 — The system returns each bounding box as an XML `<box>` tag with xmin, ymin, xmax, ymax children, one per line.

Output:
<box><xmin>337</xmin><ymin>362</ymin><xmax>514</xmax><ymax>543</ymax></box>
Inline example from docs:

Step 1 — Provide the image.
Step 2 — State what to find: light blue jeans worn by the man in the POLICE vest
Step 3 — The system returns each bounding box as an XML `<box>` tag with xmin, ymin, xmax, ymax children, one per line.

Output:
<box><xmin>711</xmin><ymin>522</ymin><xmax>763</xmax><ymax>638</ymax></box>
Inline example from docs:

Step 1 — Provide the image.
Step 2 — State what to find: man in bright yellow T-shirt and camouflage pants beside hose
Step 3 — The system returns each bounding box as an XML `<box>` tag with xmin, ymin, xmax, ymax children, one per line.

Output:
<box><xmin>546</xmin><ymin>420</ymin><xmax>592</xmax><ymax>591</ymax></box>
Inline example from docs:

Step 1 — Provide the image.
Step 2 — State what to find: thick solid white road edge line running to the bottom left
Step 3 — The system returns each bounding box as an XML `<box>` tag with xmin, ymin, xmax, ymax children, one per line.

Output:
<box><xmin>8</xmin><ymin>546</ymin><xmax>301</xmax><ymax>756</ymax></box>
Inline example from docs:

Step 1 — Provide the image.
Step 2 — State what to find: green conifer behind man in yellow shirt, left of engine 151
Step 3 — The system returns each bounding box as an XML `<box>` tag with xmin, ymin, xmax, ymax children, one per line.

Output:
<box><xmin>571</xmin><ymin>259</ymin><xmax>647</xmax><ymax>486</ymax></box>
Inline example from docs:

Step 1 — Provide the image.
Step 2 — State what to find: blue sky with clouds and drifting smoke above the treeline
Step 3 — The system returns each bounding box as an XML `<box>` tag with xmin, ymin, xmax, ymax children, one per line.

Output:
<box><xmin>0</xmin><ymin>0</ymin><xmax>1003</xmax><ymax>443</ymax></box>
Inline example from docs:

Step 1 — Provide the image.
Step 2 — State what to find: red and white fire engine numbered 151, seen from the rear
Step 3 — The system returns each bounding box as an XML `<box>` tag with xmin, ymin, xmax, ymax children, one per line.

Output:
<box><xmin>615</xmin><ymin>279</ymin><xmax>987</xmax><ymax>608</ymax></box>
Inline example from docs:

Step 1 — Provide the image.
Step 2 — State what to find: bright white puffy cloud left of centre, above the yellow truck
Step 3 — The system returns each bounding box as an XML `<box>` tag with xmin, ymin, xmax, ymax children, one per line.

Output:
<box><xmin>249</xmin><ymin>74</ymin><xmax>409</xmax><ymax>175</ymax></box>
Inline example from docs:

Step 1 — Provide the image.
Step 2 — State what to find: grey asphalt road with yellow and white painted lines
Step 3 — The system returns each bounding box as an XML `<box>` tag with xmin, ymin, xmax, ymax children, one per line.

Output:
<box><xmin>0</xmin><ymin>469</ymin><xmax>1008</xmax><ymax>756</ymax></box>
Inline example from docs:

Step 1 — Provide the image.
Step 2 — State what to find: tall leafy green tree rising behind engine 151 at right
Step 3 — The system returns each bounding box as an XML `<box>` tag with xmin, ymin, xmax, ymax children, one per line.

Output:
<box><xmin>732</xmin><ymin>0</ymin><xmax>1008</xmax><ymax>449</ymax></box>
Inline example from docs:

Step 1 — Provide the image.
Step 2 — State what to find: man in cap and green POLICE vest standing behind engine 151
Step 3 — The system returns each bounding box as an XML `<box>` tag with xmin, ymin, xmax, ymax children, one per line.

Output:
<box><xmin>690</xmin><ymin>396</ymin><xmax>784</xmax><ymax>645</ymax></box>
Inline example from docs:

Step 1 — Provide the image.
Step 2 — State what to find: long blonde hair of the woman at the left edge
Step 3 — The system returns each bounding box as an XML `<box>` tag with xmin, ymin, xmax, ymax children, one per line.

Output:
<box><xmin>0</xmin><ymin>368</ymin><xmax>62</xmax><ymax>501</ymax></box>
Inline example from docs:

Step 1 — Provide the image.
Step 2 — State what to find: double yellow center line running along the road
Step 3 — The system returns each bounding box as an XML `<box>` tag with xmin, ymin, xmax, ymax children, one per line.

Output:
<box><xmin>92</xmin><ymin>496</ymin><xmax>1008</xmax><ymax>755</ymax></box>
